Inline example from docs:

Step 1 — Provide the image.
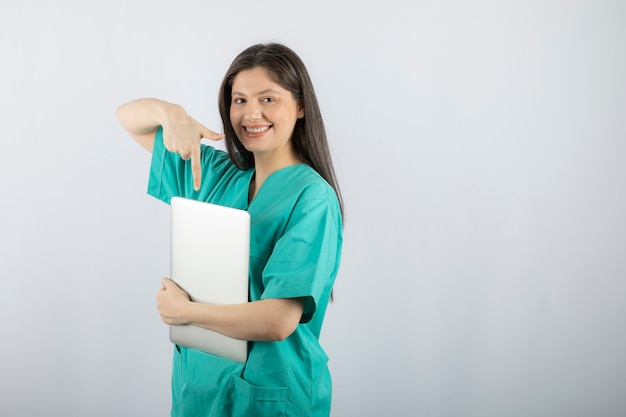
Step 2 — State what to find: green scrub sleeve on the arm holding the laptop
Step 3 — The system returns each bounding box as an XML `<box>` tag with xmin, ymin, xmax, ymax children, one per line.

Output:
<box><xmin>261</xmin><ymin>193</ymin><xmax>342</xmax><ymax>323</ymax></box>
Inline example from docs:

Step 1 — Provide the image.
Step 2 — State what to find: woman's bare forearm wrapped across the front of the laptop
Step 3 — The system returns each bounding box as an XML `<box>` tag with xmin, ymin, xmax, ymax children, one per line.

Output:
<box><xmin>181</xmin><ymin>299</ymin><xmax>304</xmax><ymax>341</ymax></box>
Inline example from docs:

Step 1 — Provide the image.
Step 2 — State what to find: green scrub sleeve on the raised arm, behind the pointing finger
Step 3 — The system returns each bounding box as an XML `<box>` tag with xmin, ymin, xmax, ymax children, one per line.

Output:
<box><xmin>148</xmin><ymin>126</ymin><xmax>232</xmax><ymax>204</ymax></box>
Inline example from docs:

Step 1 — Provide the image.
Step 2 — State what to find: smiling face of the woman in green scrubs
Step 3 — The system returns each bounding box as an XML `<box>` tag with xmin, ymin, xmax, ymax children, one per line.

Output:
<box><xmin>230</xmin><ymin>67</ymin><xmax>304</xmax><ymax>166</ymax></box>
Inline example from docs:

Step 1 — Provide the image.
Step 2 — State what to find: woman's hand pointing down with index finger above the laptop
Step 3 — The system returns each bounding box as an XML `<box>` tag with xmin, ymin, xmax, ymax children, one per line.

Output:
<box><xmin>161</xmin><ymin>104</ymin><xmax>224</xmax><ymax>191</ymax></box>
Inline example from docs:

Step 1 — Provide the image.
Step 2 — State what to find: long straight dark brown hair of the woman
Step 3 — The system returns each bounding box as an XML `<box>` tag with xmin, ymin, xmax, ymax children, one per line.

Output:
<box><xmin>219</xmin><ymin>43</ymin><xmax>343</xmax><ymax>218</ymax></box>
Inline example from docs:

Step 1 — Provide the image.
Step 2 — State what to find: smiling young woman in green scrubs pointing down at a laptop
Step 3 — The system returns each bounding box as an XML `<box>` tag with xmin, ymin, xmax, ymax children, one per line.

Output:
<box><xmin>118</xmin><ymin>44</ymin><xmax>343</xmax><ymax>417</ymax></box>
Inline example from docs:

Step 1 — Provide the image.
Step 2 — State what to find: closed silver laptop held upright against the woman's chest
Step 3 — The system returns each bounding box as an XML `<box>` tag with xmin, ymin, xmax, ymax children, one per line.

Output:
<box><xmin>170</xmin><ymin>197</ymin><xmax>250</xmax><ymax>363</ymax></box>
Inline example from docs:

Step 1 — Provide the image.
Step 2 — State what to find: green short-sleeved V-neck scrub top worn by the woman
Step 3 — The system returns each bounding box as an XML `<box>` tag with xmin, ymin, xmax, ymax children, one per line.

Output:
<box><xmin>148</xmin><ymin>127</ymin><xmax>342</xmax><ymax>417</ymax></box>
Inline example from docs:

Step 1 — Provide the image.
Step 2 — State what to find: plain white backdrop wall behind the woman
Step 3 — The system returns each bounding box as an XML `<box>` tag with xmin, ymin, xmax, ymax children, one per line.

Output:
<box><xmin>0</xmin><ymin>0</ymin><xmax>626</xmax><ymax>417</ymax></box>
